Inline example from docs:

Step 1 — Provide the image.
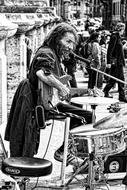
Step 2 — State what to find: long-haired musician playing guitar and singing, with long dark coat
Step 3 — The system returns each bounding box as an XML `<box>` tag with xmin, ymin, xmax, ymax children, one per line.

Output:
<box><xmin>5</xmin><ymin>23</ymin><xmax>92</xmax><ymax>164</ymax></box>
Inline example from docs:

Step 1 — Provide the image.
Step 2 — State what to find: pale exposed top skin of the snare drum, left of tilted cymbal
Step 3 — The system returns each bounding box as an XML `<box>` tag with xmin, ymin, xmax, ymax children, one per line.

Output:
<box><xmin>70</xmin><ymin>124</ymin><xmax>97</xmax><ymax>134</ymax></box>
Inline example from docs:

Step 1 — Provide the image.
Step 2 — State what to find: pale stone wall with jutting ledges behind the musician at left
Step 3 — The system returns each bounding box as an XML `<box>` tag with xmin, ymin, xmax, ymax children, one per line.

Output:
<box><xmin>0</xmin><ymin>6</ymin><xmax>59</xmax><ymax>144</ymax></box>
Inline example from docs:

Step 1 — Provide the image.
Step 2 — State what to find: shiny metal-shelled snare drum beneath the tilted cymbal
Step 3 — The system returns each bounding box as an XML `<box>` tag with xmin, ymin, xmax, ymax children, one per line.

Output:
<box><xmin>72</xmin><ymin>128</ymin><xmax>125</xmax><ymax>156</ymax></box>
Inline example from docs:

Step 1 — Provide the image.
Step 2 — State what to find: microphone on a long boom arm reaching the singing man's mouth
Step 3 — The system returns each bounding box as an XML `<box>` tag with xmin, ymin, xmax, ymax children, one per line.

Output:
<box><xmin>70</xmin><ymin>51</ymin><xmax>127</xmax><ymax>85</ymax></box>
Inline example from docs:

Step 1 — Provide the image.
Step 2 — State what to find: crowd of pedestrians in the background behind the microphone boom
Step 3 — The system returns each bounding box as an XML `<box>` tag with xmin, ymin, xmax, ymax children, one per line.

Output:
<box><xmin>62</xmin><ymin>20</ymin><xmax>127</xmax><ymax>102</ymax></box>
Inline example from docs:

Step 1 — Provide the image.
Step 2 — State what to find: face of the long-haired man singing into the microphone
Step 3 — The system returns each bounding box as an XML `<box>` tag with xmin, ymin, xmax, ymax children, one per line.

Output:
<box><xmin>59</xmin><ymin>32</ymin><xmax>76</xmax><ymax>58</ymax></box>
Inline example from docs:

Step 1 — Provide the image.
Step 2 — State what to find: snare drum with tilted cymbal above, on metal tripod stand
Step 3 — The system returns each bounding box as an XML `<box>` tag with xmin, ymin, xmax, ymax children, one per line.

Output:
<box><xmin>67</xmin><ymin>109</ymin><xmax>127</xmax><ymax>190</ymax></box>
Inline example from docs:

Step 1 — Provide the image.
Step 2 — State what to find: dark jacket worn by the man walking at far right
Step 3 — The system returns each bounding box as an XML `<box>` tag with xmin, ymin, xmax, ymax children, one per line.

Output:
<box><xmin>107</xmin><ymin>32</ymin><xmax>125</xmax><ymax>66</ymax></box>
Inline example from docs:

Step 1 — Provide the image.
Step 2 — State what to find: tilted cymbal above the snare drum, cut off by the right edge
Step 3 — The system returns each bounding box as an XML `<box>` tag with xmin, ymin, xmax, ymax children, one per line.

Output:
<box><xmin>93</xmin><ymin>109</ymin><xmax>127</xmax><ymax>129</ymax></box>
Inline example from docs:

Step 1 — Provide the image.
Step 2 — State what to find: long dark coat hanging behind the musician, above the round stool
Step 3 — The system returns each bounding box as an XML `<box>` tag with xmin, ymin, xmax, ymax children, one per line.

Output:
<box><xmin>5</xmin><ymin>79</ymin><xmax>39</xmax><ymax>157</ymax></box>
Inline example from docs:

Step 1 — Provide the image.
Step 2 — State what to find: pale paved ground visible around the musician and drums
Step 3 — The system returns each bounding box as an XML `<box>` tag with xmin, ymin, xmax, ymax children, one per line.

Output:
<box><xmin>27</xmin><ymin>70</ymin><xmax>126</xmax><ymax>190</ymax></box>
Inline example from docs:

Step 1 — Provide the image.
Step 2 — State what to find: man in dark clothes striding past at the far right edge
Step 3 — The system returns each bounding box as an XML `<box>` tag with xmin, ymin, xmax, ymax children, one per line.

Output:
<box><xmin>103</xmin><ymin>22</ymin><xmax>127</xmax><ymax>103</ymax></box>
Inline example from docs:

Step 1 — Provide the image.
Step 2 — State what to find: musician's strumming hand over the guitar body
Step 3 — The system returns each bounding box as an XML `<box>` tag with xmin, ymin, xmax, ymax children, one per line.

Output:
<box><xmin>59</xmin><ymin>85</ymin><xmax>70</xmax><ymax>100</ymax></box>
